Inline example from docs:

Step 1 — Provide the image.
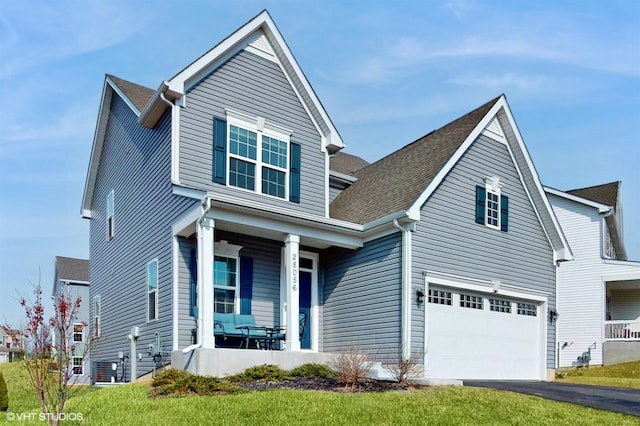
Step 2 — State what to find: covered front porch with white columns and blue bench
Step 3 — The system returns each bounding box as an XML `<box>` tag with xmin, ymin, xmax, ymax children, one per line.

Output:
<box><xmin>171</xmin><ymin>195</ymin><xmax>362</xmax><ymax>376</ymax></box>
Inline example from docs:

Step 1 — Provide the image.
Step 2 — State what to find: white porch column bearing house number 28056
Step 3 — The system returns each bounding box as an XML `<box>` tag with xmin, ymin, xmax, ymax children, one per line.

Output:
<box><xmin>284</xmin><ymin>234</ymin><xmax>300</xmax><ymax>351</ymax></box>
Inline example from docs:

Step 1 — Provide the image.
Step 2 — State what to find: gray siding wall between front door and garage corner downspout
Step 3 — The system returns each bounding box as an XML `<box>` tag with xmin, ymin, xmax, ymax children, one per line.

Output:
<box><xmin>321</xmin><ymin>233</ymin><xmax>402</xmax><ymax>362</ymax></box>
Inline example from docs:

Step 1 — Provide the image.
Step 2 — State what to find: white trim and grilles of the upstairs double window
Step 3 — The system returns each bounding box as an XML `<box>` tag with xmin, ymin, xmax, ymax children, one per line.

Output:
<box><xmin>225</xmin><ymin>109</ymin><xmax>293</xmax><ymax>200</ymax></box>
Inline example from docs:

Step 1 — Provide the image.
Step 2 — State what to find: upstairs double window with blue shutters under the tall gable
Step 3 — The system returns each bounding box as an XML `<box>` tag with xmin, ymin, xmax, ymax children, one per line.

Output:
<box><xmin>213</xmin><ymin>110</ymin><xmax>300</xmax><ymax>202</ymax></box>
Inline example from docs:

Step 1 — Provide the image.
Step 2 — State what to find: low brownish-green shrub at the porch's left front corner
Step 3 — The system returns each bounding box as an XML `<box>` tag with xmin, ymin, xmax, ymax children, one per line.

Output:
<box><xmin>149</xmin><ymin>369</ymin><xmax>241</xmax><ymax>396</ymax></box>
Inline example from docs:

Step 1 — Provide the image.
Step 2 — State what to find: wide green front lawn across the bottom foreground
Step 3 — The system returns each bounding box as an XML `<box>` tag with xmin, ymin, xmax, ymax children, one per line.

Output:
<box><xmin>0</xmin><ymin>364</ymin><xmax>638</xmax><ymax>426</ymax></box>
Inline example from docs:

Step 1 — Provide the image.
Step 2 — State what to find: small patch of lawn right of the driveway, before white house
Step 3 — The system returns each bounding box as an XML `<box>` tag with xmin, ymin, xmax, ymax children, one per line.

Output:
<box><xmin>558</xmin><ymin>361</ymin><xmax>640</xmax><ymax>389</ymax></box>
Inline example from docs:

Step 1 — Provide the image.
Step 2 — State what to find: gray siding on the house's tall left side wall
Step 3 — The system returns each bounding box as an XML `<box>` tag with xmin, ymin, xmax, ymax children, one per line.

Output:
<box><xmin>89</xmin><ymin>95</ymin><xmax>193</xmax><ymax>375</ymax></box>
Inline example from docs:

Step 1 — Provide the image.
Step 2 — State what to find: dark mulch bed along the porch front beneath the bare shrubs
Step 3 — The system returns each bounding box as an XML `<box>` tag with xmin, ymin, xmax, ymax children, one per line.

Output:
<box><xmin>239</xmin><ymin>377</ymin><xmax>422</xmax><ymax>392</ymax></box>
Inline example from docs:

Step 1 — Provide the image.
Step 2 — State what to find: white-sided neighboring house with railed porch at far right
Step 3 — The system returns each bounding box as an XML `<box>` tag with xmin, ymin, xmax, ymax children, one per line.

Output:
<box><xmin>545</xmin><ymin>182</ymin><xmax>640</xmax><ymax>367</ymax></box>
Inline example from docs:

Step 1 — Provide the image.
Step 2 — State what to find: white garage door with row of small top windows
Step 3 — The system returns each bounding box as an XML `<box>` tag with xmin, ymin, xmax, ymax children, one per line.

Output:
<box><xmin>425</xmin><ymin>287</ymin><xmax>545</xmax><ymax>380</ymax></box>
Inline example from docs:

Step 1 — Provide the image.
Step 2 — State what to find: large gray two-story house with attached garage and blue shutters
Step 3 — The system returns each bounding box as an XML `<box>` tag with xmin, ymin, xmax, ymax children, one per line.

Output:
<box><xmin>82</xmin><ymin>11</ymin><xmax>571</xmax><ymax>379</ymax></box>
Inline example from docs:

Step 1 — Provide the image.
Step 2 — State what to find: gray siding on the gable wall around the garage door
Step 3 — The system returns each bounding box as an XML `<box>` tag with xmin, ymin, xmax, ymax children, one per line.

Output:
<box><xmin>412</xmin><ymin>136</ymin><xmax>556</xmax><ymax>368</ymax></box>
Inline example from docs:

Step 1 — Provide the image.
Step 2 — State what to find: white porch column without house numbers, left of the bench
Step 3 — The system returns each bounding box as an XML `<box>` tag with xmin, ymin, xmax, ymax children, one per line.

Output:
<box><xmin>197</xmin><ymin>218</ymin><xmax>216</xmax><ymax>349</ymax></box>
